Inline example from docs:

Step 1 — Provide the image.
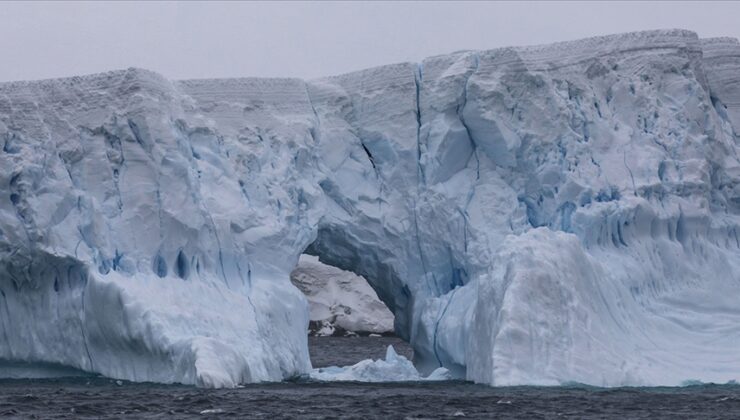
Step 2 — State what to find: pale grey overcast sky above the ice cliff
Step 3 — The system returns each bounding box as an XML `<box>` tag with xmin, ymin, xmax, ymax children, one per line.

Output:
<box><xmin>0</xmin><ymin>2</ymin><xmax>740</xmax><ymax>81</ymax></box>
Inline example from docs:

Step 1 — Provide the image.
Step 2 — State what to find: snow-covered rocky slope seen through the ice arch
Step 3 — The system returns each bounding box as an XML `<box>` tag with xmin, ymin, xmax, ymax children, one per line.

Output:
<box><xmin>290</xmin><ymin>254</ymin><xmax>393</xmax><ymax>336</ymax></box>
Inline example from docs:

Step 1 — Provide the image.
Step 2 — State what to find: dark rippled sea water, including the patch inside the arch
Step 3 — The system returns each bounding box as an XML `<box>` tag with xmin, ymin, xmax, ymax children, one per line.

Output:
<box><xmin>0</xmin><ymin>337</ymin><xmax>740</xmax><ymax>419</ymax></box>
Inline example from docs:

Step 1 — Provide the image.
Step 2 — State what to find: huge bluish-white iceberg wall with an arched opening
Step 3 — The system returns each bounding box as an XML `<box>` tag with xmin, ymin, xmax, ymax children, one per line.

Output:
<box><xmin>0</xmin><ymin>30</ymin><xmax>740</xmax><ymax>387</ymax></box>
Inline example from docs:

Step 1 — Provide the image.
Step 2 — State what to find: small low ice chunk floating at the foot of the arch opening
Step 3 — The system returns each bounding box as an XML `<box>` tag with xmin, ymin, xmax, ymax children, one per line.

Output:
<box><xmin>309</xmin><ymin>346</ymin><xmax>452</xmax><ymax>382</ymax></box>
